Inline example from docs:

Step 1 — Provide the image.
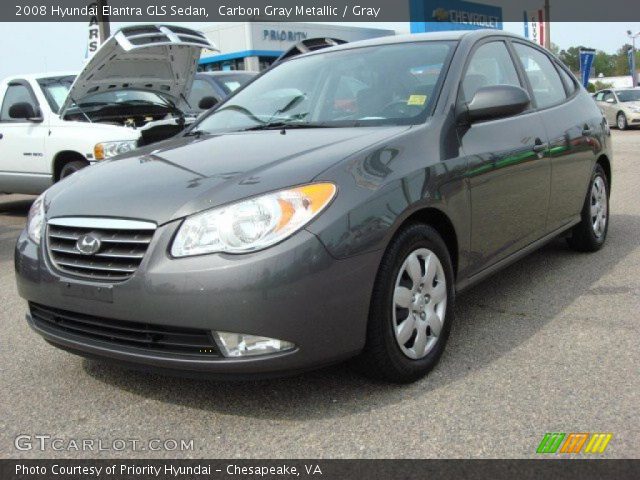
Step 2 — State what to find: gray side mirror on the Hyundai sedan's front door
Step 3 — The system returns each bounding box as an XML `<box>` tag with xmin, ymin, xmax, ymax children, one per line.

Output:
<box><xmin>462</xmin><ymin>85</ymin><xmax>531</xmax><ymax>123</ymax></box>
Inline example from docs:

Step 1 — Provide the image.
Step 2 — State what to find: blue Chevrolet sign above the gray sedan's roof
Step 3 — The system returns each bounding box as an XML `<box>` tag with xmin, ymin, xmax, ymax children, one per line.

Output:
<box><xmin>409</xmin><ymin>0</ymin><xmax>502</xmax><ymax>33</ymax></box>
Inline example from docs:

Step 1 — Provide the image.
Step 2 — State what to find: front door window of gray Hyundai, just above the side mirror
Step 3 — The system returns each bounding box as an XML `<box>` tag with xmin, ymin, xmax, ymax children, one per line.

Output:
<box><xmin>462</xmin><ymin>41</ymin><xmax>520</xmax><ymax>101</ymax></box>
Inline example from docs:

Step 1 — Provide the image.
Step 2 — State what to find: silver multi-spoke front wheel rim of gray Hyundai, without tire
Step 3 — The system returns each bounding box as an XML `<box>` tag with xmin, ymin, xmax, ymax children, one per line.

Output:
<box><xmin>393</xmin><ymin>248</ymin><xmax>447</xmax><ymax>360</ymax></box>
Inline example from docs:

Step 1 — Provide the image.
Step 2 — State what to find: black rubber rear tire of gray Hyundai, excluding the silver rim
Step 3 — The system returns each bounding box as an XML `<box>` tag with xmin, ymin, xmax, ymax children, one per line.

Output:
<box><xmin>567</xmin><ymin>163</ymin><xmax>610</xmax><ymax>252</ymax></box>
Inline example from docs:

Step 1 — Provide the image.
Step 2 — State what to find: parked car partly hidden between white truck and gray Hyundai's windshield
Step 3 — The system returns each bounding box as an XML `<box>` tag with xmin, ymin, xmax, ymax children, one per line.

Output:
<box><xmin>187</xmin><ymin>70</ymin><xmax>257</xmax><ymax>113</ymax></box>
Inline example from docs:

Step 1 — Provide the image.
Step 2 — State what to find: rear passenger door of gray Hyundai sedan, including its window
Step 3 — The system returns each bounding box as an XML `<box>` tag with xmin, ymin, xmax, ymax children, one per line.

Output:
<box><xmin>513</xmin><ymin>41</ymin><xmax>596</xmax><ymax>232</ymax></box>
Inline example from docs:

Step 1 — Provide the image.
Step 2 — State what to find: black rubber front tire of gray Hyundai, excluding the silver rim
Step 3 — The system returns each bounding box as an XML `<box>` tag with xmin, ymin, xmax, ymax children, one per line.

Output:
<box><xmin>356</xmin><ymin>224</ymin><xmax>455</xmax><ymax>383</ymax></box>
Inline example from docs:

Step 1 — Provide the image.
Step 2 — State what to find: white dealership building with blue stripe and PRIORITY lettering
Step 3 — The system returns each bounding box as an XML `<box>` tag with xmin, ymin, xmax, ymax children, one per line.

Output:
<box><xmin>200</xmin><ymin>22</ymin><xmax>395</xmax><ymax>72</ymax></box>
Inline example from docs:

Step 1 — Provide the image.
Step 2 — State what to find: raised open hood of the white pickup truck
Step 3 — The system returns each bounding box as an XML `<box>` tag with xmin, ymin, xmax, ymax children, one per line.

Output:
<box><xmin>61</xmin><ymin>25</ymin><xmax>219</xmax><ymax>114</ymax></box>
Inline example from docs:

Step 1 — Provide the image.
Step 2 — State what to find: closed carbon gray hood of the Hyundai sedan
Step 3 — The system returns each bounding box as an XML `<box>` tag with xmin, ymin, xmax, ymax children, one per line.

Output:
<box><xmin>46</xmin><ymin>126</ymin><xmax>410</xmax><ymax>225</ymax></box>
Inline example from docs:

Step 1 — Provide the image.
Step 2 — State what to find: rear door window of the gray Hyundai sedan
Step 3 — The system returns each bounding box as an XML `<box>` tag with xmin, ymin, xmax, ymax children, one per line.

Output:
<box><xmin>514</xmin><ymin>43</ymin><xmax>566</xmax><ymax>108</ymax></box>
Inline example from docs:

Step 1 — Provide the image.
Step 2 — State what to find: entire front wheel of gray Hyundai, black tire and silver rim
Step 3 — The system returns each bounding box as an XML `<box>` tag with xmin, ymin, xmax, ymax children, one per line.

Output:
<box><xmin>359</xmin><ymin>224</ymin><xmax>455</xmax><ymax>383</ymax></box>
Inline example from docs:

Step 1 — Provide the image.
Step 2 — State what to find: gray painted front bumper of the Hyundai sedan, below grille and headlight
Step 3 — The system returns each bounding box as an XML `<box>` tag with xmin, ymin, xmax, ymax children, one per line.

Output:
<box><xmin>15</xmin><ymin>222</ymin><xmax>379</xmax><ymax>376</ymax></box>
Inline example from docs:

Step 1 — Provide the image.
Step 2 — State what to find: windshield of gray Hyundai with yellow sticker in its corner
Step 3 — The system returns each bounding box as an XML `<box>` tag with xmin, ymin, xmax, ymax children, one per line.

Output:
<box><xmin>194</xmin><ymin>41</ymin><xmax>455</xmax><ymax>133</ymax></box>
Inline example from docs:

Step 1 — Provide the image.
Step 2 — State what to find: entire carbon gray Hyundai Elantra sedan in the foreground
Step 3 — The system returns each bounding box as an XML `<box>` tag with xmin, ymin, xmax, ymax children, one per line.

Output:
<box><xmin>15</xmin><ymin>31</ymin><xmax>612</xmax><ymax>382</ymax></box>
